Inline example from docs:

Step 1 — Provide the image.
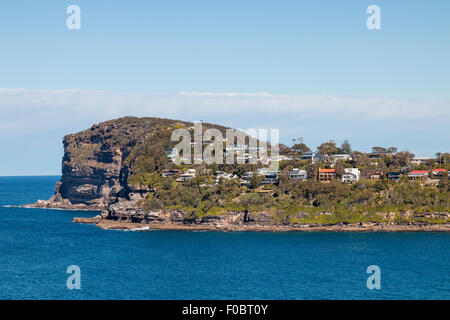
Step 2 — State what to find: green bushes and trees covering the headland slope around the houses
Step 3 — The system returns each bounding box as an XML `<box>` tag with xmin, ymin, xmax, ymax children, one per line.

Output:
<box><xmin>65</xmin><ymin>117</ymin><xmax>450</xmax><ymax>224</ymax></box>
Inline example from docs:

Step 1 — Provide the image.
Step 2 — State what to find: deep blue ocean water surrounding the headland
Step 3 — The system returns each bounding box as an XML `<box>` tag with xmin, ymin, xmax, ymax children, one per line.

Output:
<box><xmin>0</xmin><ymin>176</ymin><xmax>450</xmax><ymax>299</ymax></box>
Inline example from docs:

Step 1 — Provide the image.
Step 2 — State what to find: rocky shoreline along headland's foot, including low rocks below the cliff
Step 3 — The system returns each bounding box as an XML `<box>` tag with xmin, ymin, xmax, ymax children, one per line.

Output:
<box><xmin>22</xmin><ymin>199</ymin><xmax>450</xmax><ymax>232</ymax></box>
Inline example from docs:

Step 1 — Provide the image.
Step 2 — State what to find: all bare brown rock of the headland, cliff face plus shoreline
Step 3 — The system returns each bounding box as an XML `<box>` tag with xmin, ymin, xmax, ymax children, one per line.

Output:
<box><xmin>28</xmin><ymin>117</ymin><xmax>450</xmax><ymax>231</ymax></box>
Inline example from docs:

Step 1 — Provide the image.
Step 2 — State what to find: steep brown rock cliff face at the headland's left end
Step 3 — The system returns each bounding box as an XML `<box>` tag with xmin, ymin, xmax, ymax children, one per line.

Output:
<box><xmin>35</xmin><ymin>117</ymin><xmax>188</xmax><ymax>210</ymax></box>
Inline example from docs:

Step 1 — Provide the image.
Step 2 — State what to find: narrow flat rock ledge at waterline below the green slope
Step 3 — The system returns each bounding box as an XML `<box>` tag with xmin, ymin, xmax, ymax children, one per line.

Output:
<box><xmin>72</xmin><ymin>216</ymin><xmax>450</xmax><ymax>232</ymax></box>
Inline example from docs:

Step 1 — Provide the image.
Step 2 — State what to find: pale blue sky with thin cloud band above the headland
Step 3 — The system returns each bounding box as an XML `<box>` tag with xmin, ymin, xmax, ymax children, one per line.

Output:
<box><xmin>0</xmin><ymin>0</ymin><xmax>450</xmax><ymax>175</ymax></box>
